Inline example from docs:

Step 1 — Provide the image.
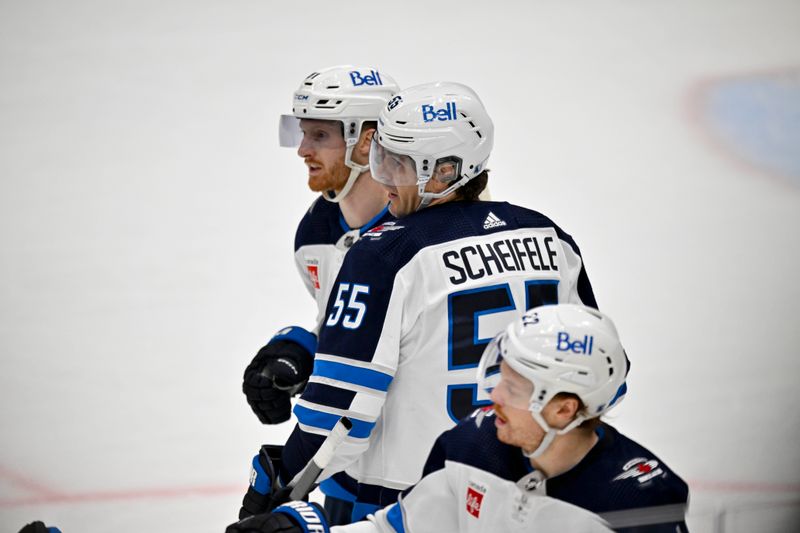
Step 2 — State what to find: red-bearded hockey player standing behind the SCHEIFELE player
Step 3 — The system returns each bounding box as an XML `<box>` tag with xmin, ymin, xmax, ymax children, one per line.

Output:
<box><xmin>242</xmin><ymin>66</ymin><xmax>398</xmax><ymax>424</ymax></box>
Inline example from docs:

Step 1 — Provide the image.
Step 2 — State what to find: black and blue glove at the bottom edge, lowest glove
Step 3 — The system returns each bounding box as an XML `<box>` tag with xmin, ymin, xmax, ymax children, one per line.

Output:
<box><xmin>225</xmin><ymin>501</ymin><xmax>330</xmax><ymax>533</ymax></box>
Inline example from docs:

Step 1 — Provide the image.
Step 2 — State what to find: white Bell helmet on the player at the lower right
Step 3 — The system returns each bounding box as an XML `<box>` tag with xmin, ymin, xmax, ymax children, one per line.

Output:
<box><xmin>478</xmin><ymin>304</ymin><xmax>627</xmax><ymax>457</ymax></box>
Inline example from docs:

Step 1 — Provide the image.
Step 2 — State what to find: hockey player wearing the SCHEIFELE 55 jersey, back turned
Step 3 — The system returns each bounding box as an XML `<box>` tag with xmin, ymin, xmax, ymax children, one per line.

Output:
<box><xmin>241</xmin><ymin>82</ymin><xmax>608</xmax><ymax>519</ymax></box>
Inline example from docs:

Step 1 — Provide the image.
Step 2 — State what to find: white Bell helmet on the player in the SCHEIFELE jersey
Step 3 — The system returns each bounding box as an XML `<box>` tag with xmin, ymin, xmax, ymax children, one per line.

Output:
<box><xmin>370</xmin><ymin>82</ymin><xmax>494</xmax><ymax>208</ymax></box>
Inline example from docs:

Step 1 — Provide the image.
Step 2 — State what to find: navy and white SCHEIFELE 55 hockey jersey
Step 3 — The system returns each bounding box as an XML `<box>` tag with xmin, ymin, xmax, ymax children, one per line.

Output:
<box><xmin>283</xmin><ymin>202</ymin><xmax>597</xmax><ymax>518</ymax></box>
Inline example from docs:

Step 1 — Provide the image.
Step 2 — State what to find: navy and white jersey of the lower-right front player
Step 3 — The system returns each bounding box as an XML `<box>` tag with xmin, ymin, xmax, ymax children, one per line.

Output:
<box><xmin>332</xmin><ymin>410</ymin><xmax>689</xmax><ymax>533</ymax></box>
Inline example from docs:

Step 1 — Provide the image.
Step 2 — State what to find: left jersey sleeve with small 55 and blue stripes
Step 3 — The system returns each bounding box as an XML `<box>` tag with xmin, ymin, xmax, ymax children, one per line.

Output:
<box><xmin>283</xmin><ymin>243</ymin><xmax>403</xmax><ymax>479</ymax></box>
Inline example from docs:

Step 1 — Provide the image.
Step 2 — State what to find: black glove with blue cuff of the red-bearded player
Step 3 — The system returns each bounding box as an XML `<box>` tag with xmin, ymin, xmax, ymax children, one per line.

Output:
<box><xmin>242</xmin><ymin>328</ymin><xmax>314</xmax><ymax>424</ymax></box>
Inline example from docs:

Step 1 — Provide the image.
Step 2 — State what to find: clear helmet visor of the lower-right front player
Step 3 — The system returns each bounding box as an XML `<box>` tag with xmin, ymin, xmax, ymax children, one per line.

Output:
<box><xmin>478</xmin><ymin>333</ymin><xmax>533</xmax><ymax>409</ymax></box>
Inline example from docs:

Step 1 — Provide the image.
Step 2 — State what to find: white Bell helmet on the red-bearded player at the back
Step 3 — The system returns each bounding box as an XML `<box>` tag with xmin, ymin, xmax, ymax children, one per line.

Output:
<box><xmin>279</xmin><ymin>65</ymin><xmax>400</xmax><ymax>202</ymax></box>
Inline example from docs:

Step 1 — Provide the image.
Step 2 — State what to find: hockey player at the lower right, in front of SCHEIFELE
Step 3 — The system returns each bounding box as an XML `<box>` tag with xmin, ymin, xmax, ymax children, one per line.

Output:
<box><xmin>228</xmin><ymin>304</ymin><xmax>688</xmax><ymax>533</ymax></box>
